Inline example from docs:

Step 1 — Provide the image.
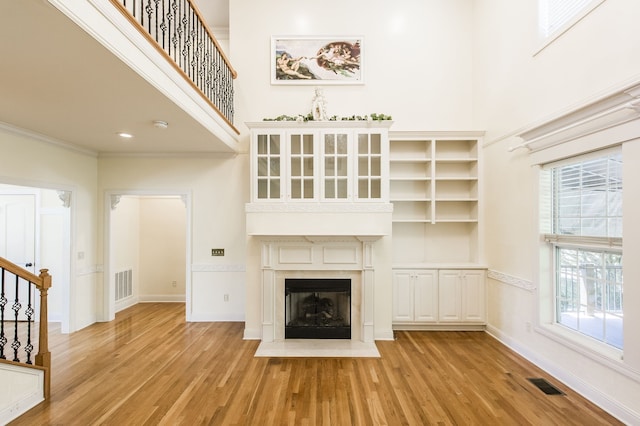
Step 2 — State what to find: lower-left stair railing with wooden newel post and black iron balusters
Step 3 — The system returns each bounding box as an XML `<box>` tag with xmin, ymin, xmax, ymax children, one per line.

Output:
<box><xmin>0</xmin><ymin>257</ymin><xmax>51</xmax><ymax>399</ymax></box>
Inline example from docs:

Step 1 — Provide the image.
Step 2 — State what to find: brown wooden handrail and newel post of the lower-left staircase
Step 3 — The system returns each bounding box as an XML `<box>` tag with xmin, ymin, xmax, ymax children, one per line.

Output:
<box><xmin>0</xmin><ymin>257</ymin><xmax>51</xmax><ymax>399</ymax></box>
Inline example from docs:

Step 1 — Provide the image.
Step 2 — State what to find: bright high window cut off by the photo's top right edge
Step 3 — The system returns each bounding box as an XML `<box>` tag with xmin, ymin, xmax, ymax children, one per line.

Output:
<box><xmin>534</xmin><ymin>0</ymin><xmax>605</xmax><ymax>56</ymax></box>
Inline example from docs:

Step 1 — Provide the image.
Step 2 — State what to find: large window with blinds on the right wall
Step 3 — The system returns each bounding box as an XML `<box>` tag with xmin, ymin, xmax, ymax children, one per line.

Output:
<box><xmin>541</xmin><ymin>149</ymin><xmax>623</xmax><ymax>349</ymax></box>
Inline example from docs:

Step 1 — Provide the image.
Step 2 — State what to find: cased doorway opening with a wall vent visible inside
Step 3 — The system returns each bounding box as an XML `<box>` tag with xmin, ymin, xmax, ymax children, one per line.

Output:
<box><xmin>104</xmin><ymin>193</ymin><xmax>190</xmax><ymax>320</ymax></box>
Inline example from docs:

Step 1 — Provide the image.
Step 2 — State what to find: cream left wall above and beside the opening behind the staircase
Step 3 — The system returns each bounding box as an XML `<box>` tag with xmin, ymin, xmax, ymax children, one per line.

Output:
<box><xmin>0</xmin><ymin>127</ymin><xmax>101</xmax><ymax>331</ymax></box>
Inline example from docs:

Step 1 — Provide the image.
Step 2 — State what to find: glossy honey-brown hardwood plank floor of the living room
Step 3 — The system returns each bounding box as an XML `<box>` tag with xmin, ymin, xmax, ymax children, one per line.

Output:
<box><xmin>11</xmin><ymin>303</ymin><xmax>621</xmax><ymax>425</ymax></box>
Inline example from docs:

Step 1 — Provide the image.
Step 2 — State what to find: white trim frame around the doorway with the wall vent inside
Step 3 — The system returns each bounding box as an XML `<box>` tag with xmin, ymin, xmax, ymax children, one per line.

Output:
<box><xmin>102</xmin><ymin>190</ymin><xmax>192</xmax><ymax>321</ymax></box>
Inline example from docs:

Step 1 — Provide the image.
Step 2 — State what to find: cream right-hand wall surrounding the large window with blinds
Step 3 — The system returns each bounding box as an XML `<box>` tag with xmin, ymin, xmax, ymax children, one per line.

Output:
<box><xmin>474</xmin><ymin>0</ymin><xmax>640</xmax><ymax>423</ymax></box>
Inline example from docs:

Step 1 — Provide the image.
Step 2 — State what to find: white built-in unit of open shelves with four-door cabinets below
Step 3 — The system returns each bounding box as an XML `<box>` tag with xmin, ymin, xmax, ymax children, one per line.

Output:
<box><xmin>389</xmin><ymin>132</ymin><xmax>485</xmax><ymax>329</ymax></box>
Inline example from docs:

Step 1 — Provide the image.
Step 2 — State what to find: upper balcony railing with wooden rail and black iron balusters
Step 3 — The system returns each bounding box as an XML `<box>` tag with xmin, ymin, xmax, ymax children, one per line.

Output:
<box><xmin>110</xmin><ymin>0</ymin><xmax>237</xmax><ymax>132</ymax></box>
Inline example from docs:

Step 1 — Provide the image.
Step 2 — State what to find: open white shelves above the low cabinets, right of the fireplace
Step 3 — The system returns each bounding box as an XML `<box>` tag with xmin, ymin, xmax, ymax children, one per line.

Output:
<box><xmin>389</xmin><ymin>132</ymin><xmax>482</xmax><ymax>266</ymax></box>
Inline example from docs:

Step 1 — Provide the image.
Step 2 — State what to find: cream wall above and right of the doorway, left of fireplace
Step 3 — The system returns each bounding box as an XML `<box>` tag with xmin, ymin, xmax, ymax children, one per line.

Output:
<box><xmin>99</xmin><ymin>155</ymin><xmax>249</xmax><ymax>321</ymax></box>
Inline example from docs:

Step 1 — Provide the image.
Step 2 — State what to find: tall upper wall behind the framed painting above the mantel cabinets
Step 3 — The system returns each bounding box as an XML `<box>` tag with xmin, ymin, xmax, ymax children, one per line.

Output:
<box><xmin>229</xmin><ymin>0</ymin><xmax>472</xmax><ymax>132</ymax></box>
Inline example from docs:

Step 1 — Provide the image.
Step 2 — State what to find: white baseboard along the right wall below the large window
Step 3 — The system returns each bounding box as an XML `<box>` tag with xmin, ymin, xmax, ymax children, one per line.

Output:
<box><xmin>486</xmin><ymin>325</ymin><xmax>640</xmax><ymax>425</ymax></box>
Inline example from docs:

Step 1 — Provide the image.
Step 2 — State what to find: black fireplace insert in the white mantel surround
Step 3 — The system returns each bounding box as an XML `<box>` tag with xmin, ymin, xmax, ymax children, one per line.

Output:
<box><xmin>284</xmin><ymin>278</ymin><xmax>351</xmax><ymax>339</ymax></box>
